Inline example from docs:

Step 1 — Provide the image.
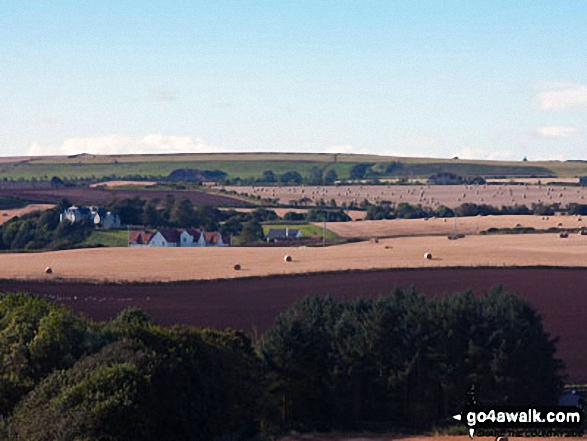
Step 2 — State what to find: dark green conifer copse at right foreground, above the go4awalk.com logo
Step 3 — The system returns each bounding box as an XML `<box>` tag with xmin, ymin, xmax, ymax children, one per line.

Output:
<box><xmin>262</xmin><ymin>288</ymin><xmax>562</xmax><ymax>429</ymax></box>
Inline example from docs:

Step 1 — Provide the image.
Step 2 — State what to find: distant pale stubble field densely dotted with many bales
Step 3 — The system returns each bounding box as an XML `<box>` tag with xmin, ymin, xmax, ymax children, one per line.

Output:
<box><xmin>223</xmin><ymin>185</ymin><xmax>587</xmax><ymax>207</ymax></box>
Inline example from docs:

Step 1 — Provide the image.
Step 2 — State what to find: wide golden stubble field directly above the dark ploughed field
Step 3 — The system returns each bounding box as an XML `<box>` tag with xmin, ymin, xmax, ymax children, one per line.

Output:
<box><xmin>0</xmin><ymin>234</ymin><xmax>587</xmax><ymax>282</ymax></box>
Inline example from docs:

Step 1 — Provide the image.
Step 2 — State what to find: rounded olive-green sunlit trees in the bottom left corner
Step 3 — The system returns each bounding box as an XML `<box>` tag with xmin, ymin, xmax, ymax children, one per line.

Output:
<box><xmin>0</xmin><ymin>294</ymin><xmax>271</xmax><ymax>441</ymax></box>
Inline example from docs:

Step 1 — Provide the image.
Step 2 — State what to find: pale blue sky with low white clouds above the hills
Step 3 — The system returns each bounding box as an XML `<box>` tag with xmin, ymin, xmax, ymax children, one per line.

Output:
<box><xmin>0</xmin><ymin>0</ymin><xmax>587</xmax><ymax>160</ymax></box>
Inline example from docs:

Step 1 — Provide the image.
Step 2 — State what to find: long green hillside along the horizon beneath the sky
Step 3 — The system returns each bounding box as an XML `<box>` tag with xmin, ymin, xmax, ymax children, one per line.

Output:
<box><xmin>0</xmin><ymin>153</ymin><xmax>587</xmax><ymax>180</ymax></box>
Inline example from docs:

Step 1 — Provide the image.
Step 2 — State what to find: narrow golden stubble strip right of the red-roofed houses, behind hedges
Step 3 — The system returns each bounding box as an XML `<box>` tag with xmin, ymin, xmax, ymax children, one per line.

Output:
<box><xmin>326</xmin><ymin>215</ymin><xmax>587</xmax><ymax>238</ymax></box>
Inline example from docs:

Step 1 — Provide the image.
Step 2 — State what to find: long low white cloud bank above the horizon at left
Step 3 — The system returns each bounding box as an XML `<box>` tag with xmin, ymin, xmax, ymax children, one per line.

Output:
<box><xmin>28</xmin><ymin>134</ymin><xmax>222</xmax><ymax>156</ymax></box>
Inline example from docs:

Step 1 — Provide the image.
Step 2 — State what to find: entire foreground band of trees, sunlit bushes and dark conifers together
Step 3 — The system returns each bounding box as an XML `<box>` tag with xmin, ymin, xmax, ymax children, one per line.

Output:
<box><xmin>0</xmin><ymin>287</ymin><xmax>563</xmax><ymax>441</ymax></box>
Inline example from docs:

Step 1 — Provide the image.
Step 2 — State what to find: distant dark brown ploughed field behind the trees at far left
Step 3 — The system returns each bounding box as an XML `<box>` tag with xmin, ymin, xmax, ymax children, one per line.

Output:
<box><xmin>0</xmin><ymin>188</ymin><xmax>246</xmax><ymax>206</ymax></box>
